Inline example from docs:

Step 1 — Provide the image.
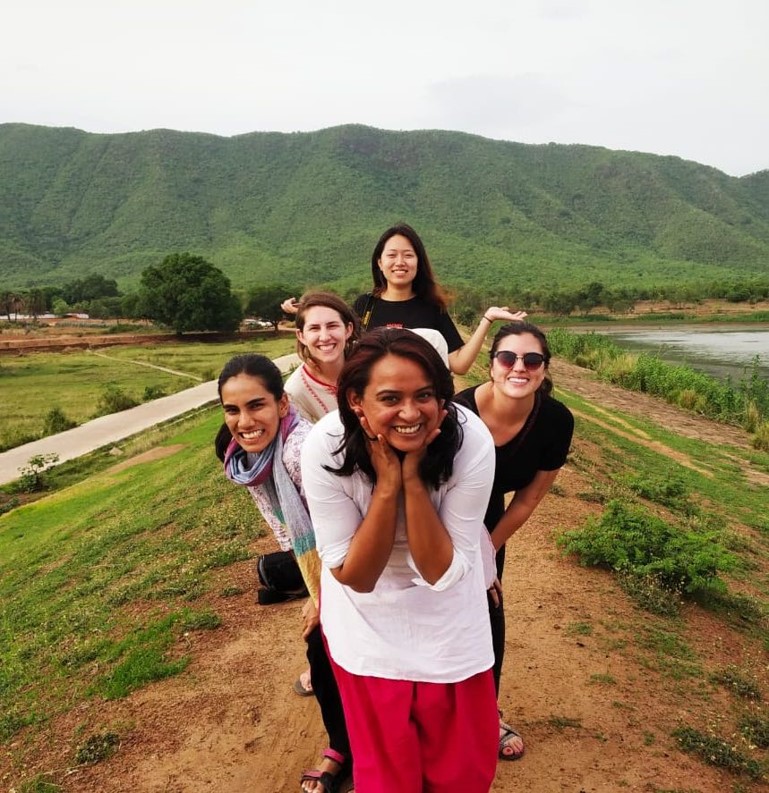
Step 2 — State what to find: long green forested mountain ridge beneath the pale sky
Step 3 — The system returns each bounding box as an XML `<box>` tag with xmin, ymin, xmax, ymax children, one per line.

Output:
<box><xmin>0</xmin><ymin>124</ymin><xmax>769</xmax><ymax>291</ymax></box>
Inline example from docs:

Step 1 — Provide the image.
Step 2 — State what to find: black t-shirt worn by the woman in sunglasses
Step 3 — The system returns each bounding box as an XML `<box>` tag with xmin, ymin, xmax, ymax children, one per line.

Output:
<box><xmin>454</xmin><ymin>386</ymin><xmax>574</xmax><ymax>531</ymax></box>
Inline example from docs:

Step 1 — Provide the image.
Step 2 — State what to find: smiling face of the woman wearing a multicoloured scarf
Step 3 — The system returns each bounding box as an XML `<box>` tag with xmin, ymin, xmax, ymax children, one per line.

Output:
<box><xmin>221</xmin><ymin>373</ymin><xmax>288</xmax><ymax>452</ymax></box>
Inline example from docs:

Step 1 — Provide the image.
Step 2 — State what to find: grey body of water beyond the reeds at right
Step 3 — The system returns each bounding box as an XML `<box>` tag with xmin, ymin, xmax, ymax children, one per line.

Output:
<box><xmin>596</xmin><ymin>327</ymin><xmax>769</xmax><ymax>382</ymax></box>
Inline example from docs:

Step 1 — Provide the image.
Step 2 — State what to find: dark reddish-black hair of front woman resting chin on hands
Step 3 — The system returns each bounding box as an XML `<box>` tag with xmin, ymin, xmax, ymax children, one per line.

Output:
<box><xmin>326</xmin><ymin>327</ymin><xmax>463</xmax><ymax>489</ymax></box>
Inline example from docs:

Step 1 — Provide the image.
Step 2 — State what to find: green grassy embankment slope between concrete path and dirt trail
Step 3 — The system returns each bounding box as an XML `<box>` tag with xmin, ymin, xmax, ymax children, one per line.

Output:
<box><xmin>0</xmin><ymin>410</ymin><xmax>262</xmax><ymax>740</ymax></box>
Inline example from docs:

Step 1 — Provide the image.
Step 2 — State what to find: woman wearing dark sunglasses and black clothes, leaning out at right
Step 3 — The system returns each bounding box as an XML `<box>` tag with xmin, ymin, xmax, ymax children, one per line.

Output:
<box><xmin>456</xmin><ymin>322</ymin><xmax>574</xmax><ymax>760</ymax></box>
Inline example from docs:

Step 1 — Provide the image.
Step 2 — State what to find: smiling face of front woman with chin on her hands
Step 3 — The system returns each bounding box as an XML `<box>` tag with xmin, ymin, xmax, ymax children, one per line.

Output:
<box><xmin>348</xmin><ymin>355</ymin><xmax>443</xmax><ymax>452</ymax></box>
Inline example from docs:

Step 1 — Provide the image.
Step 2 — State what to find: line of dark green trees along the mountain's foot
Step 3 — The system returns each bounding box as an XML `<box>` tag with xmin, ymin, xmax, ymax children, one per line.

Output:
<box><xmin>0</xmin><ymin>253</ymin><xmax>769</xmax><ymax>333</ymax></box>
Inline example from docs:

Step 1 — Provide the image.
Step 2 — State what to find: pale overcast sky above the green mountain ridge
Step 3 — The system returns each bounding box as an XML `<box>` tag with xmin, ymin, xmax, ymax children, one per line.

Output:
<box><xmin>0</xmin><ymin>0</ymin><xmax>769</xmax><ymax>176</ymax></box>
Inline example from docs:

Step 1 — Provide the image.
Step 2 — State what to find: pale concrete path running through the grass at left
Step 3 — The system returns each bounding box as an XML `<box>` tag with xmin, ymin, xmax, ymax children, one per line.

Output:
<box><xmin>0</xmin><ymin>353</ymin><xmax>299</xmax><ymax>485</ymax></box>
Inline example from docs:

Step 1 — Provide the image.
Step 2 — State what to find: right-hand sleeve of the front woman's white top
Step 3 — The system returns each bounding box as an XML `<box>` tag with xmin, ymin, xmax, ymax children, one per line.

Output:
<box><xmin>408</xmin><ymin>409</ymin><xmax>495</xmax><ymax>592</ymax></box>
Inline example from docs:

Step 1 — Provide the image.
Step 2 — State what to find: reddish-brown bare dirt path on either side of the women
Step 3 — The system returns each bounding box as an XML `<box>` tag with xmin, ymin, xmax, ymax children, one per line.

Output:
<box><xmin>7</xmin><ymin>362</ymin><xmax>769</xmax><ymax>793</ymax></box>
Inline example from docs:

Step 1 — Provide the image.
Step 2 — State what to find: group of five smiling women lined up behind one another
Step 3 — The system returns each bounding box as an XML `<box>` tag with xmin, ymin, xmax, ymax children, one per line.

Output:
<box><xmin>214</xmin><ymin>225</ymin><xmax>573</xmax><ymax>793</ymax></box>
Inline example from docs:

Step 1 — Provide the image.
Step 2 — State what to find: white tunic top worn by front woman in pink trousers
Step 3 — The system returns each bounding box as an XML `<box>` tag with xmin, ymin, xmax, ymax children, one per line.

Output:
<box><xmin>301</xmin><ymin>407</ymin><xmax>494</xmax><ymax>683</ymax></box>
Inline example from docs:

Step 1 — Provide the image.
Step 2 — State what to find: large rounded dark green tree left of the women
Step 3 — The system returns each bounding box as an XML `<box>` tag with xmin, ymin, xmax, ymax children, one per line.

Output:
<box><xmin>139</xmin><ymin>253</ymin><xmax>242</xmax><ymax>333</ymax></box>
